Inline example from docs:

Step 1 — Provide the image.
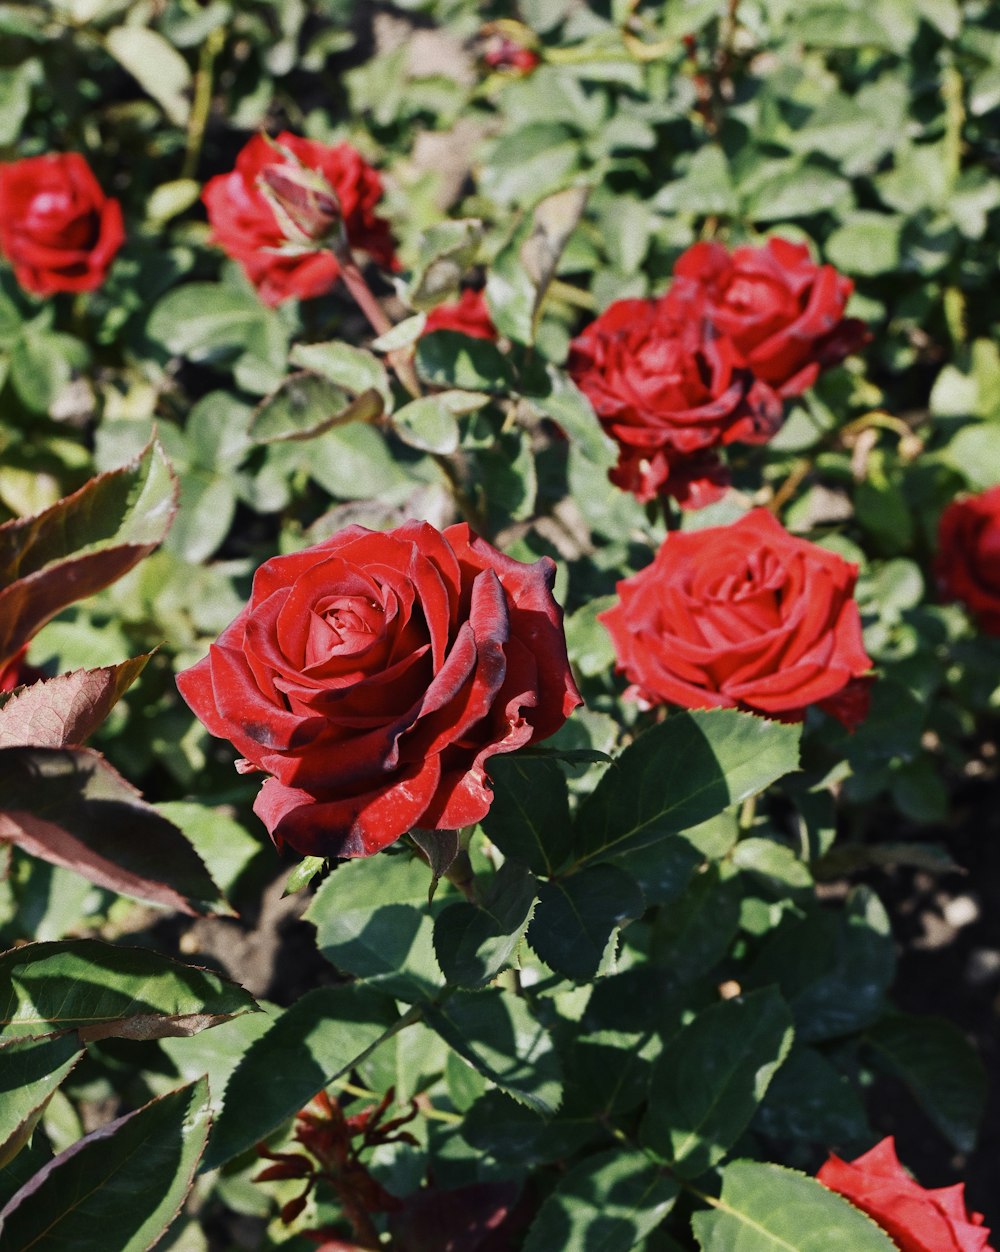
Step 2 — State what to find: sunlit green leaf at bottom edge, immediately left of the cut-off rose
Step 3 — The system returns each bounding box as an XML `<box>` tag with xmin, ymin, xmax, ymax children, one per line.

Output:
<box><xmin>691</xmin><ymin>1161</ymin><xmax>896</xmax><ymax>1252</ymax></box>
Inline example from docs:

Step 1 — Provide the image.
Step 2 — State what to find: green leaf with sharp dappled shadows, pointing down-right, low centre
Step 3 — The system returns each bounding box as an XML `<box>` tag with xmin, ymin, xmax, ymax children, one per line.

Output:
<box><xmin>426</xmin><ymin>989</ymin><xmax>562</xmax><ymax>1116</ymax></box>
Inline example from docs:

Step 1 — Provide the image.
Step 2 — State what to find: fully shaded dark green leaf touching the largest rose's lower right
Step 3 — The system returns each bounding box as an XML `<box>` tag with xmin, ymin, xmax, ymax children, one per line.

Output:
<box><xmin>482</xmin><ymin>754</ymin><xmax>573</xmax><ymax>875</ymax></box>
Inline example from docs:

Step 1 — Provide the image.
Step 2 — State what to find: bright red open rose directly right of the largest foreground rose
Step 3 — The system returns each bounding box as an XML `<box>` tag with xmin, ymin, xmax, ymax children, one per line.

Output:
<box><xmin>598</xmin><ymin>508</ymin><xmax>871</xmax><ymax>725</ymax></box>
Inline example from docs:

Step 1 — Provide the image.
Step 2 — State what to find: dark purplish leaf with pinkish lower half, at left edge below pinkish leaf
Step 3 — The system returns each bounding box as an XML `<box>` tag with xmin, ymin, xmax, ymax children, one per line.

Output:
<box><xmin>0</xmin><ymin>747</ymin><xmax>229</xmax><ymax>913</ymax></box>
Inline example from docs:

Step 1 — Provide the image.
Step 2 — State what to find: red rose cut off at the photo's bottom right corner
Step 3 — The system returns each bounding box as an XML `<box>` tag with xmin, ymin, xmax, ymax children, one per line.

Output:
<box><xmin>816</xmin><ymin>1136</ymin><xmax>991</xmax><ymax>1252</ymax></box>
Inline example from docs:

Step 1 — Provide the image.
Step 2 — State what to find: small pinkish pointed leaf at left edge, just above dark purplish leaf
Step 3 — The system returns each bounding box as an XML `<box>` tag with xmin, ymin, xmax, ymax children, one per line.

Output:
<box><xmin>0</xmin><ymin>652</ymin><xmax>153</xmax><ymax>747</ymax></box>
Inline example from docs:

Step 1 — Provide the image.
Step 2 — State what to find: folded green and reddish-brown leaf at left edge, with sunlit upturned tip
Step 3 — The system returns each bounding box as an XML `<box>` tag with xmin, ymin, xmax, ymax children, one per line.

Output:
<box><xmin>0</xmin><ymin>442</ymin><xmax>178</xmax><ymax>666</ymax></box>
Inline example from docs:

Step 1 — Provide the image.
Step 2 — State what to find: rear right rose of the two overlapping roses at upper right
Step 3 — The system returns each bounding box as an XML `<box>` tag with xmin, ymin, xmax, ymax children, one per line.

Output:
<box><xmin>667</xmin><ymin>239</ymin><xmax>871</xmax><ymax>396</ymax></box>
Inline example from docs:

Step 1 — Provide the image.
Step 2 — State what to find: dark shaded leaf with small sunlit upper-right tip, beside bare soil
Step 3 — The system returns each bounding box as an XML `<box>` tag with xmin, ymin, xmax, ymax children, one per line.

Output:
<box><xmin>745</xmin><ymin>886</ymin><xmax>895</xmax><ymax>1043</ymax></box>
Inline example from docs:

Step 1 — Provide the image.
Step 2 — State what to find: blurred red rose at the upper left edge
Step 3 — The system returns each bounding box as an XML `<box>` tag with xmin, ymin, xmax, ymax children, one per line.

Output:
<box><xmin>0</xmin><ymin>153</ymin><xmax>125</xmax><ymax>295</ymax></box>
